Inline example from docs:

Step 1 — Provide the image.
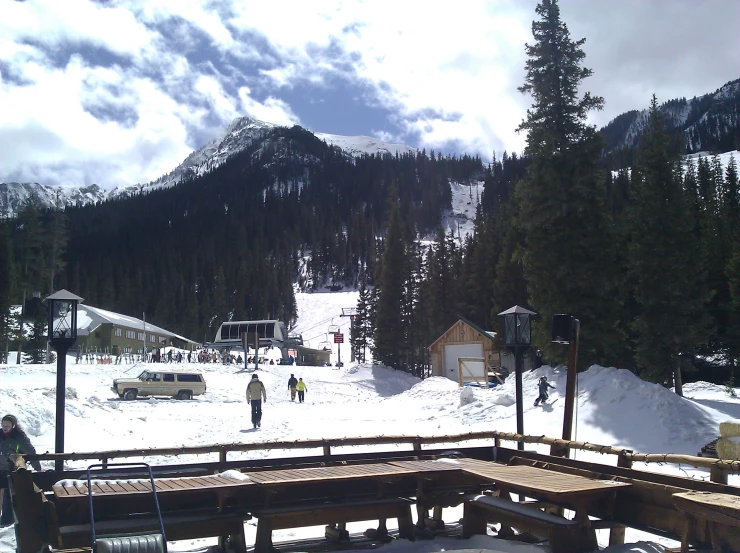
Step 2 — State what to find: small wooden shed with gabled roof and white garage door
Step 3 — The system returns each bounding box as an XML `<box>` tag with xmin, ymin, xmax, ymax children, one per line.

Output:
<box><xmin>429</xmin><ymin>317</ymin><xmax>499</xmax><ymax>382</ymax></box>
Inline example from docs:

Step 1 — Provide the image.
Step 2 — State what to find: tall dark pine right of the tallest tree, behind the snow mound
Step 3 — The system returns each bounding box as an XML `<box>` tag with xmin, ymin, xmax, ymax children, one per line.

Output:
<box><xmin>629</xmin><ymin>96</ymin><xmax>710</xmax><ymax>395</ymax></box>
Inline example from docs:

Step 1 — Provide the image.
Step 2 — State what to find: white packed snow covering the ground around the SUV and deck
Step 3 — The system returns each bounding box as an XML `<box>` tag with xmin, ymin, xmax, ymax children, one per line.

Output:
<box><xmin>0</xmin><ymin>292</ymin><xmax>740</xmax><ymax>553</ymax></box>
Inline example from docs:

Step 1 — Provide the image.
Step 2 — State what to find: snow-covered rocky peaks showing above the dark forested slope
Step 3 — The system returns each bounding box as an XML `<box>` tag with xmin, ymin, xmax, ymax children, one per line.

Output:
<box><xmin>0</xmin><ymin>117</ymin><xmax>416</xmax><ymax>216</ymax></box>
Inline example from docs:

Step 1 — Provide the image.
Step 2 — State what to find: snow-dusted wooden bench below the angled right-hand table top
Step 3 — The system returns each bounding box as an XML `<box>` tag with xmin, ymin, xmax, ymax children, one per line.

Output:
<box><xmin>463</xmin><ymin>495</ymin><xmax>593</xmax><ymax>553</ymax></box>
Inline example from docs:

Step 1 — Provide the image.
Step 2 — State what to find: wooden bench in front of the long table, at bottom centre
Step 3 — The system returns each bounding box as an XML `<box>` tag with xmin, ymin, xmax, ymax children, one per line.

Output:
<box><xmin>252</xmin><ymin>497</ymin><xmax>414</xmax><ymax>553</ymax></box>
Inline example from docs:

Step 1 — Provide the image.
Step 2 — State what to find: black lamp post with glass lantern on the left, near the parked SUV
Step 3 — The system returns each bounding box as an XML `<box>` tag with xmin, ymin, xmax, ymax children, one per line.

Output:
<box><xmin>45</xmin><ymin>290</ymin><xmax>83</xmax><ymax>472</ymax></box>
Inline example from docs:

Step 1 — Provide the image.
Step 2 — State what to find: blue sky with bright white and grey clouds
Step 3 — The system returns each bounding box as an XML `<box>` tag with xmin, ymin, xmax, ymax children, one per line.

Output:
<box><xmin>0</xmin><ymin>0</ymin><xmax>740</xmax><ymax>188</ymax></box>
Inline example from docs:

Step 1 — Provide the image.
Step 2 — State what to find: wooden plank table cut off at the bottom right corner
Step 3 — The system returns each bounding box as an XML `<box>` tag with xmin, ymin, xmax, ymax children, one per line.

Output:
<box><xmin>673</xmin><ymin>491</ymin><xmax>740</xmax><ymax>553</ymax></box>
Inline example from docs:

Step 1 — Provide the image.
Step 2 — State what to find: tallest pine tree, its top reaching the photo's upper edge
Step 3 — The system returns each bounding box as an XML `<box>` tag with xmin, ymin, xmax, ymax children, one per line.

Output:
<box><xmin>516</xmin><ymin>0</ymin><xmax>621</xmax><ymax>366</ymax></box>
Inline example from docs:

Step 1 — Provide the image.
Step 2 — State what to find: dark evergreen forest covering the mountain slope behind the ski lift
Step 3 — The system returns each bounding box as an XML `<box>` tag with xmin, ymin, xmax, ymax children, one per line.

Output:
<box><xmin>0</xmin><ymin>127</ymin><xmax>483</xmax><ymax>350</ymax></box>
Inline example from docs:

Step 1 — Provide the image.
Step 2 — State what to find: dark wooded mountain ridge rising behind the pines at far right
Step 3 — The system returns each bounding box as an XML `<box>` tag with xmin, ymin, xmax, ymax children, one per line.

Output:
<box><xmin>600</xmin><ymin>79</ymin><xmax>740</xmax><ymax>153</ymax></box>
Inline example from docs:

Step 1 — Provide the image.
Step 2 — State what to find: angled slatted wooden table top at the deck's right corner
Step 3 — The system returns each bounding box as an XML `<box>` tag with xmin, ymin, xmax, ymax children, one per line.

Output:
<box><xmin>463</xmin><ymin>461</ymin><xmax>631</xmax><ymax>496</ymax></box>
